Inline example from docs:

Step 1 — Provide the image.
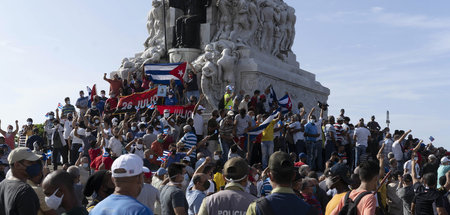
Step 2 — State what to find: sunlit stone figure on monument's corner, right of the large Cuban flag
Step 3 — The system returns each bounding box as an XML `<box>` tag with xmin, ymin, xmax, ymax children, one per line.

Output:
<box><xmin>200</xmin><ymin>52</ymin><xmax>222</xmax><ymax>109</ymax></box>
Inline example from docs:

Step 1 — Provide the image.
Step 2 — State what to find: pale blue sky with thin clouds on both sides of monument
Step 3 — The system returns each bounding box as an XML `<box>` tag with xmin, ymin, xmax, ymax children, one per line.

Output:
<box><xmin>0</xmin><ymin>0</ymin><xmax>450</xmax><ymax>149</ymax></box>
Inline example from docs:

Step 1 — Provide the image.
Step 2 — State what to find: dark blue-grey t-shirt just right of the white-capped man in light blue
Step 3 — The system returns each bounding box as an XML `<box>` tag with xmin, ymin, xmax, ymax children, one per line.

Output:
<box><xmin>160</xmin><ymin>185</ymin><xmax>189</xmax><ymax>215</ymax></box>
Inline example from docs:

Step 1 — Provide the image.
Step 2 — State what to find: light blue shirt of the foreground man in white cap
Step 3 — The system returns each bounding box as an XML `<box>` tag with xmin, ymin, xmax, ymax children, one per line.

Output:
<box><xmin>89</xmin><ymin>194</ymin><xmax>153</xmax><ymax>215</ymax></box>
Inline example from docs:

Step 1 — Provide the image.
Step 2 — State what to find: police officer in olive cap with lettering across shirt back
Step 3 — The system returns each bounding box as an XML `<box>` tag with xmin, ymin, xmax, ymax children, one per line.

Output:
<box><xmin>199</xmin><ymin>157</ymin><xmax>256</xmax><ymax>215</ymax></box>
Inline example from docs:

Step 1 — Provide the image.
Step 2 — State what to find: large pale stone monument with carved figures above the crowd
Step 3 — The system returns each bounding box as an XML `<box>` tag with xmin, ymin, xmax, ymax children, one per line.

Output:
<box><xmin>113</xmin><ymin>0</ymin><xmax>330</xmax><ymax>110</ymax></box>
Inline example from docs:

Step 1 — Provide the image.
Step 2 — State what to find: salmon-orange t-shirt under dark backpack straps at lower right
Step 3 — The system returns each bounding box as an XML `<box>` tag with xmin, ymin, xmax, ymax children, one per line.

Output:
<box><xmin>330</xmin><ymin>190</ymin><xmax>377</xmax><ymax>215</ymax></box>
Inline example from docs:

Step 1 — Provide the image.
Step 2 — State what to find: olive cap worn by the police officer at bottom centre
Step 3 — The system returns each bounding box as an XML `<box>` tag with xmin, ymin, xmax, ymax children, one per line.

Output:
<box><xmin>223</xmin><ymin>157</ymin><xmax>249</xmax><ymax>181</ymax></box>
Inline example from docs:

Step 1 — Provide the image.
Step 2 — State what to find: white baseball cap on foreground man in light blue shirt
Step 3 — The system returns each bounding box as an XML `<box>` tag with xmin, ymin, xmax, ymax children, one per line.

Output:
<box><xmin>111</xmin><ymin>154</ymin><xmax>146</xmax><ymax>178</ymax></box>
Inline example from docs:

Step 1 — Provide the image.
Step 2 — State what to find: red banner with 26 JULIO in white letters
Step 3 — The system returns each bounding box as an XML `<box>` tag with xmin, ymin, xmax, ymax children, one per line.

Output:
<box><xmin>116</xmin><ymin>88</ymin><xmax>158</xmax><ymax>113</ymax></box>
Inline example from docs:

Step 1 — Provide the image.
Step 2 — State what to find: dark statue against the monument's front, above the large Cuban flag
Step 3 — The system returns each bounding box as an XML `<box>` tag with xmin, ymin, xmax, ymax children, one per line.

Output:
<box><xmin>169</xmin><ymin>0</ymin><xmax>211</xmax><ymax>48</ymax></box>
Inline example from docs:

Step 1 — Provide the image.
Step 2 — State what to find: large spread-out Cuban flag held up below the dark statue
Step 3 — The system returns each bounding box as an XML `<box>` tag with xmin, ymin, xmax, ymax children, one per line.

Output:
<box><xmin>144</xmin><ymin>62</ymin><xmax>187</xmax><ymax>85</ymax></box>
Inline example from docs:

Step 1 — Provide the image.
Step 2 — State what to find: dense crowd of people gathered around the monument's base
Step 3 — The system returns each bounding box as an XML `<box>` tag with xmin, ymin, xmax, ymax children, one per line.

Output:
<box><xmin>0</xmin><ymin>69</ymin><xmax>450</xmax><ymax>215</ymax></box>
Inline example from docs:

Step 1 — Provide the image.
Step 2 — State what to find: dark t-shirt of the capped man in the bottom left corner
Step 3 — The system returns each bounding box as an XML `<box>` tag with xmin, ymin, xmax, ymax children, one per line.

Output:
<box><xmin>0</xmin><ymin>179</ymin><xmax>40</xmax><ymax>215</ymax></box>
